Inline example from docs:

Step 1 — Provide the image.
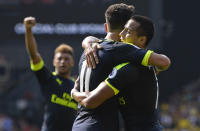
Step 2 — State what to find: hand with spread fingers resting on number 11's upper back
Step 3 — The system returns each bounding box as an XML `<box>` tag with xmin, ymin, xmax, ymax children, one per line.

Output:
<box><xmin>84</xmin><ymin>43</ymin><xmax>102</xmax><ymax>69</ymax></box>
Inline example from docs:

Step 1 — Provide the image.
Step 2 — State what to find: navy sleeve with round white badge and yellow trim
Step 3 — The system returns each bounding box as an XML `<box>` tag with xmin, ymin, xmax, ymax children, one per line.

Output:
<box><xmin>105</xmin><ymin>63</ymin><xmax>138</xmax><ymax>95</ymax></box>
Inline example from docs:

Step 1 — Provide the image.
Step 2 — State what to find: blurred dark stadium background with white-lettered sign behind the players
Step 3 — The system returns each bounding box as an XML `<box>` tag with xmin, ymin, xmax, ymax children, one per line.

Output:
<box><xmin>0</xmin><ymin>0</ymin><xmax>200</xmax><ymax>131</ymax></box>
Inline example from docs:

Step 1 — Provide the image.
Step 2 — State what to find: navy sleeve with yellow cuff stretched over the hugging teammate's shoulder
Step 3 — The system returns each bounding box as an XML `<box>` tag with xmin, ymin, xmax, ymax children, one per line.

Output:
<box><xmin>113</xmin><ymin>43</ymin><xmax>153</xmax><ymax>66</ymax></box>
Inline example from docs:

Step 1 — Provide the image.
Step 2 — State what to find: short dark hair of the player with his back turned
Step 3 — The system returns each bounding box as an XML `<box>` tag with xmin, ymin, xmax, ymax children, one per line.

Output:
<box><xmin>105</xmin><ymin>3</ymin><xmax>135</xmax><ymax>31</ymax></box>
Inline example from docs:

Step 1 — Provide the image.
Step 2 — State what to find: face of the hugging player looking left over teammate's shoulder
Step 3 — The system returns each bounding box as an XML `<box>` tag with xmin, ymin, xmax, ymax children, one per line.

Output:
<box><xmin>120</xmin><ymin>19</ymin><xmax>139</xmax><ymax>45</ymax></box>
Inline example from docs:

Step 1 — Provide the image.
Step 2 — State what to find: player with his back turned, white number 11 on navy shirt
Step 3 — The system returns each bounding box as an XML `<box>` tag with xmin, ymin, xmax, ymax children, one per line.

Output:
<box><xmin>72</xmin><ymin>4</ymin><xmax>170</xmax><ymax>131</ymax></box>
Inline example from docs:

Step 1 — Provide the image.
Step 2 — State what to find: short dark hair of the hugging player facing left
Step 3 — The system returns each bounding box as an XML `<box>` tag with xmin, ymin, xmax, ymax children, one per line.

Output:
<box><xmin>131</xmin><ymin>15</ymin><xmax>154</xmax><ymax>46</ymax></box>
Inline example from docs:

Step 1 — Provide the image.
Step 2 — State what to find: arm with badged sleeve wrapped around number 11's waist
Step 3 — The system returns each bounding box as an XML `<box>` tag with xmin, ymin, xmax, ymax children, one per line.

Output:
<box><xmin>72</xmin><ymin>63</ymin><xmax>134</xmax><ymax>109</ymax></box>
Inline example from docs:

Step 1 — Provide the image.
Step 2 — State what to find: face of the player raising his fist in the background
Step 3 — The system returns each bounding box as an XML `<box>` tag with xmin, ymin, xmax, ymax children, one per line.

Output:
<box><xmin>53</xmin><ymin>52</ymin><xmax>74</xmax><ymax>74</ymax></box>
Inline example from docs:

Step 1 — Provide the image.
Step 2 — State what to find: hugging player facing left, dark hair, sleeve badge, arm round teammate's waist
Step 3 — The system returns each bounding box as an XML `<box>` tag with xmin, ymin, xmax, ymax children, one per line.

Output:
<box><xmin>72</xmin><ymin>16</ymin><xmax>169</xmax><ymax>131</ymax></box>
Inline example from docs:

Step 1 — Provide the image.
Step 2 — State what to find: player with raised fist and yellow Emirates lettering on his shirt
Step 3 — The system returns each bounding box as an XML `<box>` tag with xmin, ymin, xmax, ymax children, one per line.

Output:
<box><xmin>24</xmin><ymin>17</ymin><xmax>77</xmax><ymax>131</ymax></box>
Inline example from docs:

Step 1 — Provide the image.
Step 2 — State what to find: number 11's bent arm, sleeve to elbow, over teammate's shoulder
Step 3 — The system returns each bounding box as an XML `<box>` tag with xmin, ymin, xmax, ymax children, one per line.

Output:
<box><xmin>114</xmin><ymin>44</ymin><xmax>171</xmax><ymax>71</ymax></box>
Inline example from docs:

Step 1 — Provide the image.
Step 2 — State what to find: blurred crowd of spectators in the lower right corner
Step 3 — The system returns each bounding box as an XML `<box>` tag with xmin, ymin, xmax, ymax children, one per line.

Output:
<box><xmin>160</xmin><ymin>78</ymin><xmax>200</xmax><ymax>131</ymax></box>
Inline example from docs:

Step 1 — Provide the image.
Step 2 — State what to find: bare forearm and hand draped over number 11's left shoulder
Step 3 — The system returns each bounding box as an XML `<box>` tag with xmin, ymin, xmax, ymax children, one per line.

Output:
<box><xmin>82</xmin><ymin>36</ymin><xmax>101</xmax><ymax>69</ymax></box>
